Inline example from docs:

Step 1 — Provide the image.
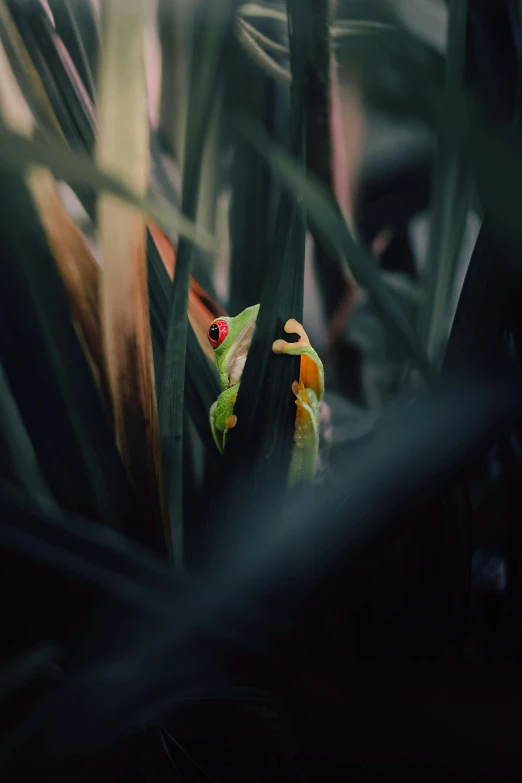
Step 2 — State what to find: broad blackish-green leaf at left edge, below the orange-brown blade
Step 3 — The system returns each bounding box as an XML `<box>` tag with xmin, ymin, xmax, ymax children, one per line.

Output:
<box><xmin>0</xmin><ymin>174</ymin><xmax>143</xmax><ymax>538</ymax></box>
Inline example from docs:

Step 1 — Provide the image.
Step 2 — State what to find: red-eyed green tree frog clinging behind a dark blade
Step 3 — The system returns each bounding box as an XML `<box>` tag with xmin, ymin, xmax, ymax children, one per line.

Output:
<box><xmin>208</xmin><ymin>305</ymin><xmax>324</xmax><ymax>485</ymax></box>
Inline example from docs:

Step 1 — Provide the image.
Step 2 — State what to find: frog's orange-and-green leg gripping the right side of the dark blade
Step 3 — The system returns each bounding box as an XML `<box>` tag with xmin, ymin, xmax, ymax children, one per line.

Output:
<box><xmin>272</xmin><ymin>318</ymin><xmax>324</xmax><ymax>484</ymax></box>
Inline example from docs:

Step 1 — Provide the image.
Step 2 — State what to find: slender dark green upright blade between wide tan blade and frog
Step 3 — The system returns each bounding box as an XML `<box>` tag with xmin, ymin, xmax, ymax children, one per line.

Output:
<box><xmin>160</xmin><ymin>0</ymin><xmax>244</xmax><ymax>569</ymax></box>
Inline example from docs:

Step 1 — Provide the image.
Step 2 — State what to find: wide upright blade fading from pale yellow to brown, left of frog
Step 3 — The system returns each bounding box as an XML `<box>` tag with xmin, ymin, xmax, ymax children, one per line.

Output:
<box><xmin>96</xmin><ymin>0</ymin><xmax>172</xmax><ymax>552</ymax></box>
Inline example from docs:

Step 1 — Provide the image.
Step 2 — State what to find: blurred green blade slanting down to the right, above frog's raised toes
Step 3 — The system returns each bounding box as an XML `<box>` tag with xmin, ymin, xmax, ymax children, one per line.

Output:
<box><xmin>238</xmin><ymin>118</ymin><xmax>431</xmax><ymax>375</ymax></box>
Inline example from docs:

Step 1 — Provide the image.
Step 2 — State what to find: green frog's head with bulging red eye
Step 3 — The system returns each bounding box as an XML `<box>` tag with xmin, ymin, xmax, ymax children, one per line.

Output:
<box><xmin>208</xmin><ymin>305</ymin><xmax>259</xmax><ymax>388</ymax></box>
